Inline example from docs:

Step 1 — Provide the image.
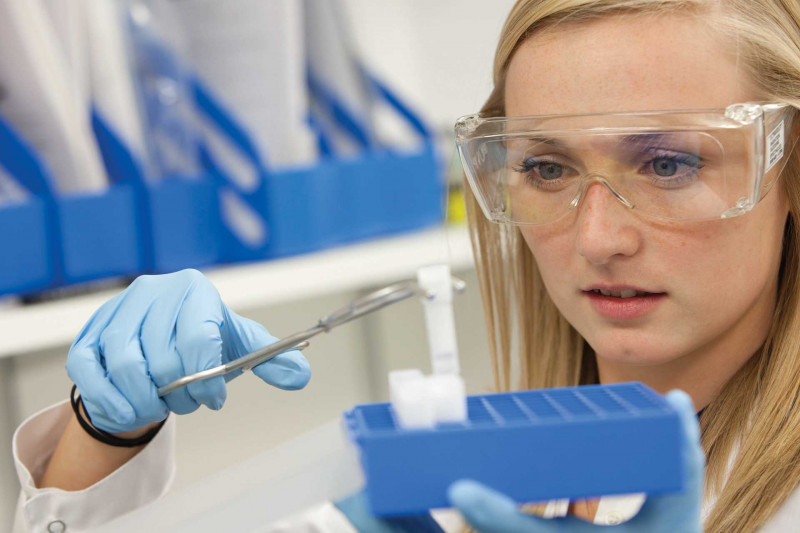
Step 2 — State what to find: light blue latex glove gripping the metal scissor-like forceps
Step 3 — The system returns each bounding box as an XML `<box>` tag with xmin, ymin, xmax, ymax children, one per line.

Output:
<box><xmin>67</xmin><ymin>270</ymin><xmax>311</xmax><ymax>433</ymax></box>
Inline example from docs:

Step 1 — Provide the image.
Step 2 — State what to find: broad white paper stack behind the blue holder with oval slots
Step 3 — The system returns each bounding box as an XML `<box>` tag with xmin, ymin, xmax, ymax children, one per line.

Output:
<box><xmin>173</xmin><ymin>0</ymin><xmax>317</xmax><ymax>168</ymax></box>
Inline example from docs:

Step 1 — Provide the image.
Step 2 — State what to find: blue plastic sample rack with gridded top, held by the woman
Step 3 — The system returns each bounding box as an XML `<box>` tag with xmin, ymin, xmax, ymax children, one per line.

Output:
<box><xmin>344</xmin><ymin>383</ymin><xmax>684</xmax><ymax>516</ymax></box>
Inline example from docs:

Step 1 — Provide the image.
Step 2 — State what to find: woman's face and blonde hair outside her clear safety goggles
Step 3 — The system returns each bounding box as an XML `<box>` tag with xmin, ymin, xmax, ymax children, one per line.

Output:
<box><xmin>456</xmin><ymin>0</ymin><xmax>800</xmax><ymax>532</ymax></box>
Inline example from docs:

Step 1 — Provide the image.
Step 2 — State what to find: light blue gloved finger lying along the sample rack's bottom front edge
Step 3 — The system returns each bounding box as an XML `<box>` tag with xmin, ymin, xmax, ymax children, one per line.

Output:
<box><xmin>447</xmin><ymin>479</ymin><xmax>597</xmax><ymax>533</ymax></box>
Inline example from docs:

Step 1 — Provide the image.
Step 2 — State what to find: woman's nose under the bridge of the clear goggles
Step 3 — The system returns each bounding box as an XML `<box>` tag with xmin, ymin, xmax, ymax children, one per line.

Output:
<box><xmin>575</xmin><ymin>181</ymin><xmax>642</xmax><ymax>266</ymax></box>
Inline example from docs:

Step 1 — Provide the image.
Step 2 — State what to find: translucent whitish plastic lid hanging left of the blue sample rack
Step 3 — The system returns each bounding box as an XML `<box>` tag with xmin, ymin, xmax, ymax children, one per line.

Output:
<box><xmin>97</xmin><ymin>420</ymin><xmax>364</xmax><ymax>533</ymax></box>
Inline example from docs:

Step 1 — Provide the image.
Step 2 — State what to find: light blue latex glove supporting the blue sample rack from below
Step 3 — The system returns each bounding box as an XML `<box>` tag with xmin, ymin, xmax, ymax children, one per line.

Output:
<box><xmin>448</xmin><ymin>390</ymin><xmax>705</xmax><ymax>533</ymax></box>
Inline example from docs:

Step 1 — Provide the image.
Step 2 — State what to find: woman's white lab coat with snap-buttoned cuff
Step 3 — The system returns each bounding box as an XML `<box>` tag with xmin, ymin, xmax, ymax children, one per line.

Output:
<box><xmin>13</xmin><ymin>402</ymin><xmax>800</xmax><ymax>533</ymax></box>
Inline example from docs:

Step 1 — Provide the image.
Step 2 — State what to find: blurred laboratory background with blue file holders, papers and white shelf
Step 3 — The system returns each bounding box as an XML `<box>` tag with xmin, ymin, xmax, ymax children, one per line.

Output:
<box><xmin>0</xmin><ymin>0</ymin><xmax>513</xmax><ymax>530</ymax></box>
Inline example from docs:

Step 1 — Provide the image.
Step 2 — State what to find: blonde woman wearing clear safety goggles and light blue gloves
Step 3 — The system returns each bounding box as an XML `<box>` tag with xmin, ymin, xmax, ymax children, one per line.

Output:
<box><xmin>10</xmin><ymin>0</ymin><xmax>800</xmax><ymax>532</ymax></box>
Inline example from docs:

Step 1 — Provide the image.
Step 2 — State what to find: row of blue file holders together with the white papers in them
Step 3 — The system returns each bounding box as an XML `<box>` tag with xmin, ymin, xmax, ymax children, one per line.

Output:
<box><xmin>0</xmin><ymin>0</ymin><xmax>444</xmax><ymax>296</ymax></box>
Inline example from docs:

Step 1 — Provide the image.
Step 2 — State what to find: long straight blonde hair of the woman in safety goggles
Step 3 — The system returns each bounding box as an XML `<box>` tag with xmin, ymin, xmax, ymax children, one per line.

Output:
<box><xmin>467</xmin><ymin>0</ymin><xmax>800</xmax><ymax>533</ymax></box>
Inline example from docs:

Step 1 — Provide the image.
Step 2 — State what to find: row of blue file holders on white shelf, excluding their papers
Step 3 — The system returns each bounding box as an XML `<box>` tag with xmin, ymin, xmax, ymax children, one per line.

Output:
<box><xmin>0</xmin><ymin>52</ymin><xmax>444</xmax><ymax>295</ymax></box>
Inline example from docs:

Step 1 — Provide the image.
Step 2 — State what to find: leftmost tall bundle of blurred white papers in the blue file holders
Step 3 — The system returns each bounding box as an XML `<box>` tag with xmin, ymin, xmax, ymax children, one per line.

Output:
<box><xmin>0</xmin><ymin>0</ymin><xmax>108</xmax><ymax>193</ymax></box>
